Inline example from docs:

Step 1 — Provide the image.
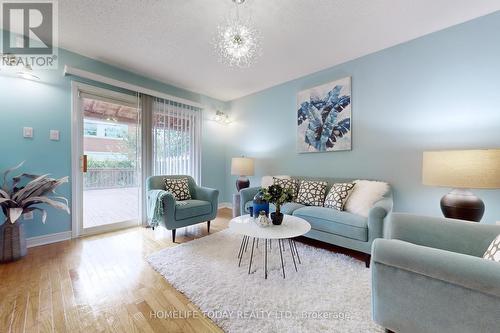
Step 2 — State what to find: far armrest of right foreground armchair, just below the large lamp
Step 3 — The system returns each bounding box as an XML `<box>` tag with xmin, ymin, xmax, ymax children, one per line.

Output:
<box><xmin>387</xmin><ymin>213</ymin><xmax>500</xmax><ymax>257</ymax></box>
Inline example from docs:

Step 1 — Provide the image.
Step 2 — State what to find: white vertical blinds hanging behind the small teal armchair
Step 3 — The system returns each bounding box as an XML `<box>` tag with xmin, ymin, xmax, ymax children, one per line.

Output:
<box><xmin>152</xmin><ymin>98</ymin><xmax>202</xmax><ymax>184</ymax></box>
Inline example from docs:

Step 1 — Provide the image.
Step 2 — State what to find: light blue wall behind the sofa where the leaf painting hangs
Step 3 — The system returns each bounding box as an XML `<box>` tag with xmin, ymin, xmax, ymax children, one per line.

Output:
<box><xmin>226</xmin><ymin>12</ymin><xmax>500</xmax><ymax>223</ymax></box>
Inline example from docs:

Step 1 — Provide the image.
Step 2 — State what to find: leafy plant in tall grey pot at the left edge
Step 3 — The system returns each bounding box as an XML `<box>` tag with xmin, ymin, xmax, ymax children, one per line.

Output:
<box><xmin>0</xmin><ymin>162</ymin><xmax>70</xmax><ymax>262</ymax></box>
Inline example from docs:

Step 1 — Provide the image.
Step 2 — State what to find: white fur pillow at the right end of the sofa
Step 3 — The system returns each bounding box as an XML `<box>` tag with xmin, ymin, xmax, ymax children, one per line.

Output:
<box><xmin>344</xmin><ymin>180</ymin><xmax>389</xmax><ymax>217</ymax></box>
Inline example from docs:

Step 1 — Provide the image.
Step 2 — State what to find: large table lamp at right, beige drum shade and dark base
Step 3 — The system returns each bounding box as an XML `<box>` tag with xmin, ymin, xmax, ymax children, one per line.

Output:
<box><xmin>422</xmin><ymin>149</ymin><xmax>500</xmax><ymax>222</ymax></box>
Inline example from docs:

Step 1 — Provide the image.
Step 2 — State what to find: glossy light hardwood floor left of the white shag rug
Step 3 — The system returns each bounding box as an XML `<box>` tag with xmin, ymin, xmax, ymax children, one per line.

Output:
<box><xmin>0</xmin><ymin>209</ymin><xmax>231</xmax><ymax>333</ymax></box>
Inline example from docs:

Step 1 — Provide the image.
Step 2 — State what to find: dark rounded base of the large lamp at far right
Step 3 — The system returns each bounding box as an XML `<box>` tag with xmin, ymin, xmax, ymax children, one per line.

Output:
<box><xmin>441</xmin><ymin>189</ymin><xmax>484</xmax><ymax>222</ymax></box>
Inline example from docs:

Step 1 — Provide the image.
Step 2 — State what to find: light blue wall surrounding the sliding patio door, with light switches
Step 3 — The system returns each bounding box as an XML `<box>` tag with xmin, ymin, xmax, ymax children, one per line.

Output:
<box><xmin>0</xmin><ymin>44</ymin><xmax>227</xmax><ymax>237</ymax></box>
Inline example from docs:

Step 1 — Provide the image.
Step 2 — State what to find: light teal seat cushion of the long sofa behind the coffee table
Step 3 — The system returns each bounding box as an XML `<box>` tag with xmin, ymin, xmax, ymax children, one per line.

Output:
<box><xmin>293</xmin><ymin>207</ymin><xmax>368</xmax><ymax>242</ymax></box>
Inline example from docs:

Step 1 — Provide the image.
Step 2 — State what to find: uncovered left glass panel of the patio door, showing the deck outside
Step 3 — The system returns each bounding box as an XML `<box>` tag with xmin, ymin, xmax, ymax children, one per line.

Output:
<box><xmin>78</xmin><ymin>88</ymin><xmax>142</xmax><ymax>234</ymax></box>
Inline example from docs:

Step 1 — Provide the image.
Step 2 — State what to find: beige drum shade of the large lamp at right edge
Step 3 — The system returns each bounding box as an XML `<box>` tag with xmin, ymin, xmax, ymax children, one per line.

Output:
<box><xmin>422</xmin><ymin>149</ymin><xmax>500</xmax><ymax>189</ymax></box>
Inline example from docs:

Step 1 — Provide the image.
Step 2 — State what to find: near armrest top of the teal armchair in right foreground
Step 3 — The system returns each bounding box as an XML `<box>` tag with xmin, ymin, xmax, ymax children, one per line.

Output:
<box><xmin>372</xmin><ymin>239</ymin><xmax>500</xmax><ymax>297</ymax></box>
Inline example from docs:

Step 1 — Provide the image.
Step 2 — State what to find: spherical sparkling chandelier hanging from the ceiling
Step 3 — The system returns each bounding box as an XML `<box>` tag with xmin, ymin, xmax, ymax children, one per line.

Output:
<box><xmin>215</xmin><ymin>0</ymin><xmax>262</xmax><ymax>68</ymax></box>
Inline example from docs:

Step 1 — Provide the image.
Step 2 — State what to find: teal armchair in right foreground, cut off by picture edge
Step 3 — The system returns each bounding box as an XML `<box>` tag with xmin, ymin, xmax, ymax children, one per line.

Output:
<box><xmin>372</xmin><ymin>214</ymin><xmax>500</xmax><ymax>333</ymax></box>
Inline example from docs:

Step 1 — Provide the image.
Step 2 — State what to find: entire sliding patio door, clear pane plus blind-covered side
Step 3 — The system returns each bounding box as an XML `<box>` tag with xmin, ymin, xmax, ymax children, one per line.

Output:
<box><xmin>72</xmin><ymin>82</ymin><xmax>202</xmax><ymax>237</ymax></box>
